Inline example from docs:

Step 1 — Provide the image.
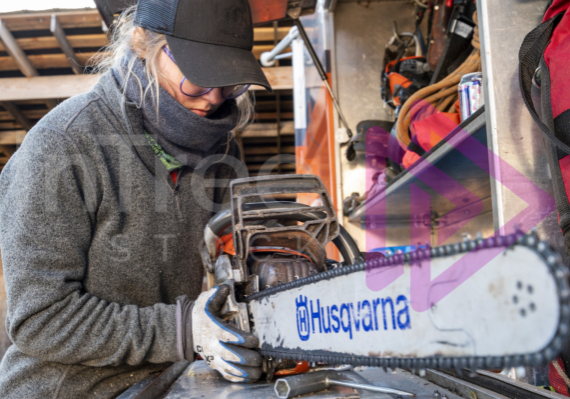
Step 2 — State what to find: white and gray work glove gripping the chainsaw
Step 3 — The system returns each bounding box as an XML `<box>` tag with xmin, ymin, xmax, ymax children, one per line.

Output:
<box><xmin>176</xmin><ymin>285</ymin><xmax>261</xmax><ymax>382</ymax></box>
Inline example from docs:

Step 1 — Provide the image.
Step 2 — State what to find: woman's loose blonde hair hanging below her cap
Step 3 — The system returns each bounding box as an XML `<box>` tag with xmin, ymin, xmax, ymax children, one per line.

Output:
<box><xmin>92</xmin><ymin>5</ymin><xmax>255</xmax><ymax>131</ymax></box>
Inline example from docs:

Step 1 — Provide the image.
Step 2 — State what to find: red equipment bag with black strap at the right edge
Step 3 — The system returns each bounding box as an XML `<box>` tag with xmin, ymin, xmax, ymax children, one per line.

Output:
<box><xmin>519</xmin><ymin>0</ymin><xmax>570</xmax><ymax>254</ymax></box>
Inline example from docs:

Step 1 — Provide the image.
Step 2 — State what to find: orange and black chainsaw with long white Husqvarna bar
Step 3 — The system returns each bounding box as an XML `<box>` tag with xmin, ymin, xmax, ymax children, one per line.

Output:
<box><xmin>201</xmin><ymin>175</ymin><xmax>570</xmax><ymax>378</ymax></box>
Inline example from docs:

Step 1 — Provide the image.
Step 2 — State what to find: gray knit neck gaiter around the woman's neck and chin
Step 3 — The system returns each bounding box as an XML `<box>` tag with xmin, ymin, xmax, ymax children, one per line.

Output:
<box><xmin>113</xmin><ymin>53</ymin><xmax>238</xmax><ymax>168</ymax></box>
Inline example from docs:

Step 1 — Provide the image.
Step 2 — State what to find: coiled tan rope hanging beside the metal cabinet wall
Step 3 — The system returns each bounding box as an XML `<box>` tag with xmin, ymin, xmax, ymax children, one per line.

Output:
<box><xmin>396</xmin><ymin>11</ymin><xmax>481</xmax><ymax>148</ymax></box>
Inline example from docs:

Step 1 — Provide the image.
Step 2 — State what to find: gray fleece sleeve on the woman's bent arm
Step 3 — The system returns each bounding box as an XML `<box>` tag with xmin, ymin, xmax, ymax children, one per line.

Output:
<box><xmin>0</xmin><ymin>128</ymin><xmax>178</xmax><ymax>367</ymax></box>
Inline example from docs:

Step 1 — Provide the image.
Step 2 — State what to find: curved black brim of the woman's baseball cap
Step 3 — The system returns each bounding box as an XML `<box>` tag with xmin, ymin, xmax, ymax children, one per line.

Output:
<box><xmin>166</xmin><ymin>35</ymin><xmax>273</xmax><ymax>92</ymax></box>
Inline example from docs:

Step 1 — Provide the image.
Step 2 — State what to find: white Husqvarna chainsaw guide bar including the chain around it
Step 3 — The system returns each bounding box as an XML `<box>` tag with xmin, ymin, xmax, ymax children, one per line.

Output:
<box><xmin>245</xmin><ymin>233</ymin><xmax>570</xmax><ymax>370</ymax></box>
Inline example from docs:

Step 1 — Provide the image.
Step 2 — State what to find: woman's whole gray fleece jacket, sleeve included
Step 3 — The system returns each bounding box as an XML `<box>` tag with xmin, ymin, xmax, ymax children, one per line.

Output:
<box><xmin>0</xmin><ymin>73</ymin><xmax>239</xmax><ymax>399</ymax></box>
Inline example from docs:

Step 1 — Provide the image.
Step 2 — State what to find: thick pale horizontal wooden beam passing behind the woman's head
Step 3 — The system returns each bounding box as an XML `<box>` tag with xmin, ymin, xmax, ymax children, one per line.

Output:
<box><xmin>0</xmin><ymin>67</ymin><xmax>293</xmax><ymax>101</ymax></box>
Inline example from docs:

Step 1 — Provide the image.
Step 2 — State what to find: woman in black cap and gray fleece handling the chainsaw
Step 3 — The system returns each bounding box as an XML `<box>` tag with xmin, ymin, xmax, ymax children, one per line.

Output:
<box><xmin>0</xmin><ymin>0</ymin><xmax>270</xmax><ymax>399</ymax></box>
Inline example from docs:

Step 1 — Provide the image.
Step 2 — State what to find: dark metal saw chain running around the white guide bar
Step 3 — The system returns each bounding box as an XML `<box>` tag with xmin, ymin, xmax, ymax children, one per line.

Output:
<box><xmin>245</xmin><ymin>232</ymin><xmax>570</xmax><ymax>370</ymax></box>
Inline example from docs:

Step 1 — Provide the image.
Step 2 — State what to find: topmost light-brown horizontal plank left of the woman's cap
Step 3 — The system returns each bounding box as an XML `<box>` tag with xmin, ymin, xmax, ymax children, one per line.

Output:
<box><xmin>2</xmin><ymin>10</ymin><xmax>103</xmax><ymax>32</ymax></box>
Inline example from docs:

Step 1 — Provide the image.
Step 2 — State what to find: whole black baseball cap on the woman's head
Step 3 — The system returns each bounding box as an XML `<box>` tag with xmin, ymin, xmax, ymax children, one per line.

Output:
<box><xmin>134</xmin><ymin>0</ymin><xmax>272</xmax><ymax>91</ymax></box>
